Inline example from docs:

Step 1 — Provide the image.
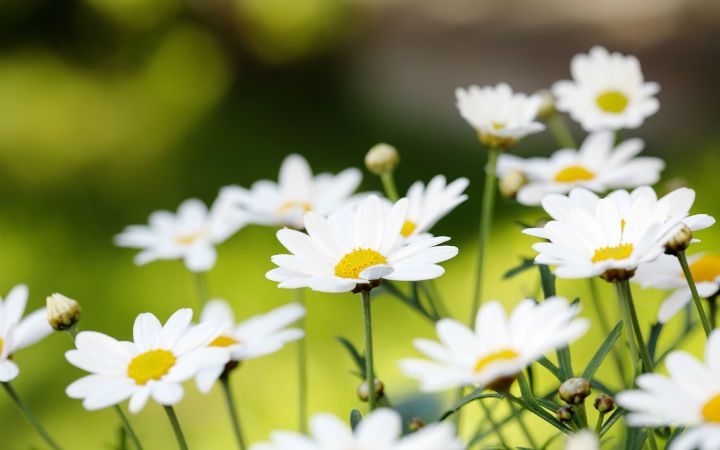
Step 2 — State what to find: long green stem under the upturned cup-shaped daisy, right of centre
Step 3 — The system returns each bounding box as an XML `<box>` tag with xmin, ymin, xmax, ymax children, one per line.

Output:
<box><xmin>469</xmin><ymin>149</ymin><xmax>500</xmax><ymax>325</ymax></box>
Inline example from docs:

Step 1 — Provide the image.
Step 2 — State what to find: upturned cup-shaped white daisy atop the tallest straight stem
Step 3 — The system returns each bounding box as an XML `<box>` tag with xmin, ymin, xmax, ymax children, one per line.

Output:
<box><xmin>455</xmin><ymin>83</ymin><xmax>545</xmax><ymax>148</ymax></box>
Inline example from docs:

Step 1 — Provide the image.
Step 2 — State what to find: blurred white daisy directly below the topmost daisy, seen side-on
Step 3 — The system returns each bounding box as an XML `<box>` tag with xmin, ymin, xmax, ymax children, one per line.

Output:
<box><xmin>498</xmin><ymin>131</ymin><xmax>665</xmax><ymax>206</ymax></box>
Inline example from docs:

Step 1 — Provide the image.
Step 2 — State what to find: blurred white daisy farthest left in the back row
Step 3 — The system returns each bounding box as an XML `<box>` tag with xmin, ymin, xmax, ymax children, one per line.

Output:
<box><xmin>115</xmin><ymin>198</ymin><xmax>247</xmax><ymax>272</ymax></box>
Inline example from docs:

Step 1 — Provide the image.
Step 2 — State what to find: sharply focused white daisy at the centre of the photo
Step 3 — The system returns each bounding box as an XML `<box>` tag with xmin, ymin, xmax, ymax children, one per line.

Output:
<box><xmin>266</xmin><ymin>195</ymin><xmax>458</xmax><ymax>292</ymax></box>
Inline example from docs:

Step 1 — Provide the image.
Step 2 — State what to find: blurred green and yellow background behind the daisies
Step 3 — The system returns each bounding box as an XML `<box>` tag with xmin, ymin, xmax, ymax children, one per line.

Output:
<box><xmin>0</xmin><ymin>0</ymin><xmax>720</xmax><ymax>450</ymax></box>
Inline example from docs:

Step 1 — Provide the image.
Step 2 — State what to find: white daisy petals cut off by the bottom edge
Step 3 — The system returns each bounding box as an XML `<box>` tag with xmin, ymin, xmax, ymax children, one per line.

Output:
<box><xmin>250</xmin><ymin>408</ymin><xmax>465</xmax><ymax>450</ymax></box>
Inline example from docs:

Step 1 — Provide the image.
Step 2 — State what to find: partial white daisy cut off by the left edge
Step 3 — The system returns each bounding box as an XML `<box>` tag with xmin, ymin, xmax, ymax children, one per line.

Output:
<box><xmin>0</xmin><ymin>284</ymin><xmax>53</xmax><ymax>383</ymax></box>
